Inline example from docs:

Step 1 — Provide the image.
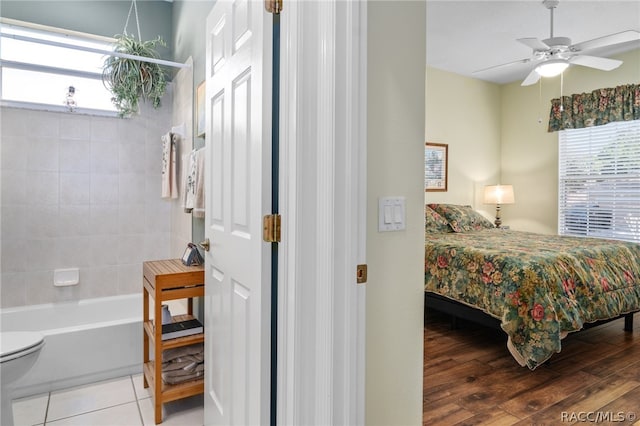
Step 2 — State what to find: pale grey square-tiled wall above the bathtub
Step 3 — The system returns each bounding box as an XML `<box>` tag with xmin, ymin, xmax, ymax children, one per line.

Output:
<box><xmin>0</xmin><ymin>93</ymin><xmax>172</xmax><ymax>307</ymax></box>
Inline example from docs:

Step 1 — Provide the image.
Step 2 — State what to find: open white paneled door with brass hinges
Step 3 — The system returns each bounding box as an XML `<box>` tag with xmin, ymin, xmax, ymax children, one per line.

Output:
<box><xmin>205</xmin><ymin>0</ymin><xmax>272</xmax><ymax>425</ymax></box>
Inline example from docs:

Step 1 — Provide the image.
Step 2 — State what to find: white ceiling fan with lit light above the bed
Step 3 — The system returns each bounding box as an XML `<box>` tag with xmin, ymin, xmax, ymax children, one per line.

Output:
<box><xmin>475</xmin><ymin>0</ymin><xmax>640</xmax><ymax>86</ymax></box>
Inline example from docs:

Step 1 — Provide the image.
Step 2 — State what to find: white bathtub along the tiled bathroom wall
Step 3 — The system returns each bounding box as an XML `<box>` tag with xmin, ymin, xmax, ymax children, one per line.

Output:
<box><xmin>0</xmin><ymin>294</ymin><xmax>142</xmax><ymax>397</ymax></box>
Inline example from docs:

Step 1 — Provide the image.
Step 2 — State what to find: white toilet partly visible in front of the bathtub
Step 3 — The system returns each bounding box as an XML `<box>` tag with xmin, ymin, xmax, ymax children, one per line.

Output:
<box><xmin>0</xmin><ymin>331</ymin><xmax>44</xmax><ymax>426</ymax></box>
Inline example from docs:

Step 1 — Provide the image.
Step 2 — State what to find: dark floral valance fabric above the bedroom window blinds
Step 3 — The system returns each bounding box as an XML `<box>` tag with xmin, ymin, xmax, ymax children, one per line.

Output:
<box><xmin>549</xmin><ymin>84</ymin><xmax>640</xmax><ymax>132</ymax></box>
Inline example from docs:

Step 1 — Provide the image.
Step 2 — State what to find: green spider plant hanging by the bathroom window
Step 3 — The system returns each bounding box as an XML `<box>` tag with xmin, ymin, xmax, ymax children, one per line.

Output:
<box><xmin>102</xmin><ymin>34</ymin><xmax>167</xmax><ymax>117</ymax></box>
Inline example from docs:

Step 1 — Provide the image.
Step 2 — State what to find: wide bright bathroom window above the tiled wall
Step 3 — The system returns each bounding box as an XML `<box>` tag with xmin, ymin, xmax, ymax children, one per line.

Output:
<box><xmin>0</xmin><ymin>19</ymin><xmax>116</xmax><ymax>115</ymax></box>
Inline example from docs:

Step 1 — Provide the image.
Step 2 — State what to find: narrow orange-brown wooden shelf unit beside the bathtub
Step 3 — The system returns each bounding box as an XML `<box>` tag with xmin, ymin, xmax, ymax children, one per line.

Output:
<box><xmin>142</xmin><ymin>259</ymin><xmax>204</xmax><ymax>424</ymax></box>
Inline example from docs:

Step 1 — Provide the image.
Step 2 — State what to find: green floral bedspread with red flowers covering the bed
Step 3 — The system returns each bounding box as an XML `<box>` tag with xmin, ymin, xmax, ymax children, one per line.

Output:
<box><xmin>425</xmin><ymin>229</ymin><xmax>640</xmax><ymax>369</ymax></box>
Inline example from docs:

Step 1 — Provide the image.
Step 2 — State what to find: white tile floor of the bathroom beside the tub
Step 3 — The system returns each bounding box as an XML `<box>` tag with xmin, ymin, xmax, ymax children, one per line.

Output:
<box><xmin>13</xmin><ymin>374</ymin><xmax>204</xmax><ymax>426</ymax></box>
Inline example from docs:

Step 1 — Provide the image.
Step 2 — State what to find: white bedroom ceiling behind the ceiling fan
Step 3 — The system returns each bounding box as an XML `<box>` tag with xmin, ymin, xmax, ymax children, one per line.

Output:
<box><xmin>427</xmin><ymin>0</ymin><xmax>640</xmax><ymax>84</ymax></box>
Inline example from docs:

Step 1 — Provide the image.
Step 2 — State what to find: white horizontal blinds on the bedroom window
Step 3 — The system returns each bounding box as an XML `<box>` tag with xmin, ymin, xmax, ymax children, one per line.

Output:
<box><xmin>558</xmin><ymin>120</ymin><xmax>640</xmax><ymax>242</ymax></box>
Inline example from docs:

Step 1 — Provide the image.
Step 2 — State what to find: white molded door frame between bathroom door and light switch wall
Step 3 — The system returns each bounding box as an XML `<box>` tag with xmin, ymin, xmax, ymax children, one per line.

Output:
<box><xmin>277</xmin><ymin>0</ymin><xmax>367</xmax><ymax>425</ymax></box>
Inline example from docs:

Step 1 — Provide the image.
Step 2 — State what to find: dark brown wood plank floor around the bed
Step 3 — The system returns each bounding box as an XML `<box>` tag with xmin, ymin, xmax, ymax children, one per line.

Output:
<box><xmin>423</xmin><ymin>311</ymin><xmax>640</xmax><ymax>426</ymax></box>
